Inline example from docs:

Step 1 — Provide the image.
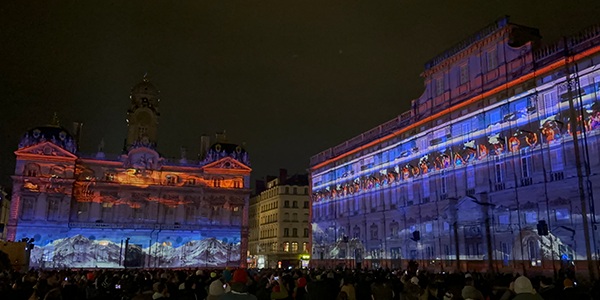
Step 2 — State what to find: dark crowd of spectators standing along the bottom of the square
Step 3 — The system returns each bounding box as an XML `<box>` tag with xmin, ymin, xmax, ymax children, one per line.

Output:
<box><xmin>0</xmin><ymin>269</ymin><xmax>600</xmax><ymax>300</ymax></box>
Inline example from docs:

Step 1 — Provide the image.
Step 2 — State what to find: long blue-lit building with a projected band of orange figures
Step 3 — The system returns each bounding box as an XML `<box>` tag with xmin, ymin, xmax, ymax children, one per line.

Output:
<box><xmin>310</xmin><ymin>18</ymin><xmax>600</xmax><ymax>271</ymax></box>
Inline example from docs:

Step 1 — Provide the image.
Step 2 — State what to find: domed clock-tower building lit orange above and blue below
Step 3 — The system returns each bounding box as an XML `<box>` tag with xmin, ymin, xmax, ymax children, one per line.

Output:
<box><xmin>7</xmin><ymin>78</ymin><xmax>251</xmax><ymax>268</ymax></box>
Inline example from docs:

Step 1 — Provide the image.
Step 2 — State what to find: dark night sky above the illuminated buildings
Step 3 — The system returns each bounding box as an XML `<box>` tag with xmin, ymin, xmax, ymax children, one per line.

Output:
<box><xmin>0</xmin><ymin>0</ymin><xmax>600</xmax><ymax>190</ymax></box>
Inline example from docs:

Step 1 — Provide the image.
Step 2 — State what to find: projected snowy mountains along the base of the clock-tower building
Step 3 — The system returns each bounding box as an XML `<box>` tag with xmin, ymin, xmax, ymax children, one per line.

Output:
<box><xmin>30</xmin><ymin>235</ymin><xmax>240</xmax><ymax>268</ymax></box>
